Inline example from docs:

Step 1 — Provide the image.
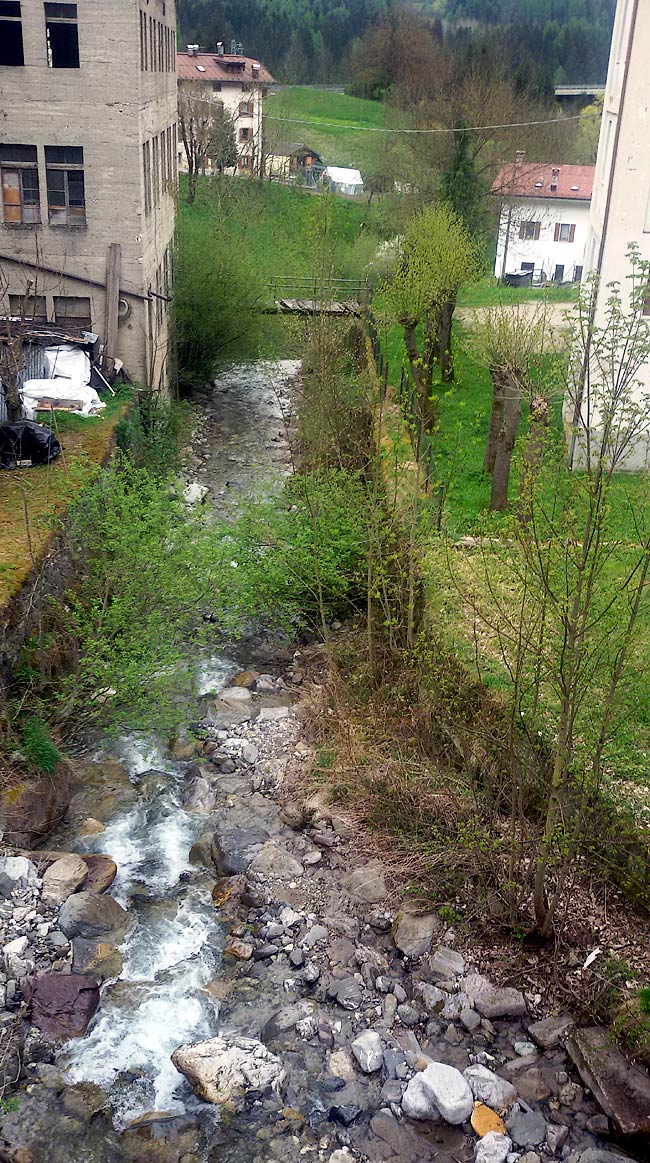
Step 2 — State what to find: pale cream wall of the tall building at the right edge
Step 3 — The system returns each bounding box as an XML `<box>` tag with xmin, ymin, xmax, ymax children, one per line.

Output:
<box><xmin>565</xmin><ymin>0</ymin><xmax>650</xmax><ymax>469</ymax></box>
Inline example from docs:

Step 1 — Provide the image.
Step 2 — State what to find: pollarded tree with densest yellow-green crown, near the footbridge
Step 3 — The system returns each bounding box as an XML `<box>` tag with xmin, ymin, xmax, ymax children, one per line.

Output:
<box><xmin>384</xmin><ymin>202</ymin><xmax>481</xmax><ymax>428</ymax></box>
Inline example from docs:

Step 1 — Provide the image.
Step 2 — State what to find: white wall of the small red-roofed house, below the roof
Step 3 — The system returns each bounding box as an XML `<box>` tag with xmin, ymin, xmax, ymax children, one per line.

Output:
<box><xmin>494</xmin><ymin>198</ymin><xmax>590</xmax><ymax>281</ymax></box>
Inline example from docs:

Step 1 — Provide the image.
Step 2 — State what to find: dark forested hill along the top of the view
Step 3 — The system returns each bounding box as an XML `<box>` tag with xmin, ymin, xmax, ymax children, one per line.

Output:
<box><xmin>179</xmin><ymin>0</ymin><xmax>615</xmax><ymax>92</ymax></box>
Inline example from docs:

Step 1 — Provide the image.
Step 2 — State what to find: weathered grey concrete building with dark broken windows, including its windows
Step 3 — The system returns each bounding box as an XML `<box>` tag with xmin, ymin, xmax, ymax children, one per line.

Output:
<box><xmin>0</xmin><ymin>0</ymin><xmax>177</xmax><ymax>386</ymax></box>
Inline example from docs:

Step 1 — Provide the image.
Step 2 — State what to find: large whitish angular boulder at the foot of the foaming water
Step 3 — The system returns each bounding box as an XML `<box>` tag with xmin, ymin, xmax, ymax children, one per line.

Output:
<box><xmin>172</xmin><ymin>1037</ymin><xmax>285</xmax><ymax>1103</ymax></box>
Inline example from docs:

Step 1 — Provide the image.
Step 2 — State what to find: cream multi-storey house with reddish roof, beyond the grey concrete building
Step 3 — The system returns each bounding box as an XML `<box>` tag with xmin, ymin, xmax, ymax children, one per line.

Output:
<box><xmin>177</xmin><ymin>43</ymin><xmax>274</xmax><ymax>176</ymax></box>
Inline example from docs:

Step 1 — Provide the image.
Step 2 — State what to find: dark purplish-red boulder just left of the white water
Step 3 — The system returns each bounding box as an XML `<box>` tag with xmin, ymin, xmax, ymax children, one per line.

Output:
<box><xmin>23</xmin><ymin>973</ymin><xmax>99</xmax><ymax>1041</ymax></box>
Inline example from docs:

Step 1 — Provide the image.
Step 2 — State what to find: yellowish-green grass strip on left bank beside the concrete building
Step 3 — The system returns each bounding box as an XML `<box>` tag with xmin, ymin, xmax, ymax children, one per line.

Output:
<box><xmin>0</xmin><ymin>395</ymin><xmax>128</xmax><ymax>606</ymax></box>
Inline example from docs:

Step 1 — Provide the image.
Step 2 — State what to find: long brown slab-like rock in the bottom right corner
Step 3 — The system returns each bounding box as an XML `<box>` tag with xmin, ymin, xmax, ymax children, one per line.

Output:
<box><xmin>566</xmin><ymin>1026</ymin><xmax>650</xmax><ymax>1141</ymax></box>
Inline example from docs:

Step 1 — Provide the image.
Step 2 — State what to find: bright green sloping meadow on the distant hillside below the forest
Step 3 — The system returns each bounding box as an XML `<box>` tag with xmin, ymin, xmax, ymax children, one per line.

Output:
<box><xmin>264</xmin><ymin>88</ymin><xmax>395</xmax><ymax>171</ymax></box>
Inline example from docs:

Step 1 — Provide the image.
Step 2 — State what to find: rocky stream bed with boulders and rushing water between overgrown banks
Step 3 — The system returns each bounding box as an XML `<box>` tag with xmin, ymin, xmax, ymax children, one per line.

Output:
<box><xmin>0</xmin><ymin>355</ymin><xmax>650</xmax><ymax>1163</ymax></box>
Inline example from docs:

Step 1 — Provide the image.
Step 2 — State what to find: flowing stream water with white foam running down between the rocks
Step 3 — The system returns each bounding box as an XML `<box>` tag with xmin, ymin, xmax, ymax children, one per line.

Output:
<box><xmin>58</xmin><ymin>361</ymin><xmax>300</xmax><ymax>1127</ymax></box>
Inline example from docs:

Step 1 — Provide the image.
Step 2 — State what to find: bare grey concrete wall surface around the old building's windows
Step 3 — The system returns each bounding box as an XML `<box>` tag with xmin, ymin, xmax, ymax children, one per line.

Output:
<box><xmin>0</xmin><ymin>0</ymin><xmax>176</xmax><ymax>383</ymax></box>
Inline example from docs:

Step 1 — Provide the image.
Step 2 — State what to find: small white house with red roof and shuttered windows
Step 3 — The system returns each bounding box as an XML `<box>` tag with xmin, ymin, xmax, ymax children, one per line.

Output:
<box><xmin>492</xmin><ymin>157</ymin><xmax>594</xmax><ymax>283</ymax></box>
